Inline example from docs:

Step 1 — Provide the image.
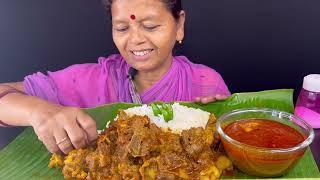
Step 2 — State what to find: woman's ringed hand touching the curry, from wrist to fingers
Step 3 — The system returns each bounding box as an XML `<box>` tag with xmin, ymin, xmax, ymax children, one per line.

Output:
<box><xmin>29</xmin><ymin>104</ymin><xmax>98</xmax><ymax>154</ymax></box>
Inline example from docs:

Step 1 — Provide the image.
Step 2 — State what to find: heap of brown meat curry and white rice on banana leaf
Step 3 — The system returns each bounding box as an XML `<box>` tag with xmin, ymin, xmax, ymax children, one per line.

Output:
<box><xmin>49</xmin><ymin>103</ymin><xmax>233</xmax><ymax>180</ymax></box>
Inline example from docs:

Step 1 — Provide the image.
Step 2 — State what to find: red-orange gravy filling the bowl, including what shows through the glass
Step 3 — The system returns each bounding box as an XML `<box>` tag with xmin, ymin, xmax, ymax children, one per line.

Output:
<box><xmin>221</xmin><ymin>119</ymin><xmax>305</xmax><ymax>177</ymax></box>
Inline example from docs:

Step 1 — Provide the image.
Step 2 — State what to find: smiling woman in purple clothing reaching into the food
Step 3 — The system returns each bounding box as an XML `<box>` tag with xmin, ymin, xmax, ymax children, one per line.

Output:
<box><xmin>0</xmin><ymin>0</ymin><xmax>230</xmax><ymax>153</ymax></box>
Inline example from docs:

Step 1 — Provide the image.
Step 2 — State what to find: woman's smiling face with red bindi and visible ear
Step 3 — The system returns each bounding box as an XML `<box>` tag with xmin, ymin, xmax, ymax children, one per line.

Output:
<box><xmin>111</xmin><ymin>0</ymin><xmax>185</xmax><ymax>72</ymax></box>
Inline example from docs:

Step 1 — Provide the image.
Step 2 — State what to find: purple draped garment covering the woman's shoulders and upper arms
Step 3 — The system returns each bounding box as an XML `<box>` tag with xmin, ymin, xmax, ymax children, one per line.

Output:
<box><xmin>24</xmin><ymin>54</ymin><xmax>230</xmax><ymax>107</ymax></box>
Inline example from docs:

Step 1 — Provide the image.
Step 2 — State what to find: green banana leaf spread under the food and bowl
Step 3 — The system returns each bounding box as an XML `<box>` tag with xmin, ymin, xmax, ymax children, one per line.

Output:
<box><xmin>0</xmin><ymin>89</ymin><xmax>320</xmax><ymax>180</ymax></box>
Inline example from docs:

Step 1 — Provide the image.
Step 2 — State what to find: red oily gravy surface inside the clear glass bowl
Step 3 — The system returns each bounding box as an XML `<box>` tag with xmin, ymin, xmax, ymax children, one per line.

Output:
<box><xmin>224</xmin><ymin>119</ymin><xmax>305</xmax><ymax>148</ymax></box>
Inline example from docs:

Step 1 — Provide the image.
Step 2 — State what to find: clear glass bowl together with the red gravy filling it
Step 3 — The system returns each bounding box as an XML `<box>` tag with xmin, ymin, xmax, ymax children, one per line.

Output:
<box><xmin>216</xmin><ymin>109</ymin><xmax>314</xmax><ymax>177</ymax></box>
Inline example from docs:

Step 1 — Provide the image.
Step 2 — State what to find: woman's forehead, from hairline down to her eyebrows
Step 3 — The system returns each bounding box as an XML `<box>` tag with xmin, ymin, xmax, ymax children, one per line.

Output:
<box><xmin>111</xmin><ymin>0</ymin><xmax>170</xmax><ymax>20</ymax></box>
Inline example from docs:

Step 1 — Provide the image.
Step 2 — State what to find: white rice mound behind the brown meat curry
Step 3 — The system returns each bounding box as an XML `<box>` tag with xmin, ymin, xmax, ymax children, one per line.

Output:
<box><xmin>115</xmin><ymin>103</ymin><xmax>210</xmax><ymax>134</ymax></box>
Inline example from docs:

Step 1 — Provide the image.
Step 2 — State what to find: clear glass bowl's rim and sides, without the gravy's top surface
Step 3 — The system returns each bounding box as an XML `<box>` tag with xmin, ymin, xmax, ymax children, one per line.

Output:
<box><xmin>216</xmin><ymin>108</ymin><xmax>314</xmax><ymax>177</ymax></box>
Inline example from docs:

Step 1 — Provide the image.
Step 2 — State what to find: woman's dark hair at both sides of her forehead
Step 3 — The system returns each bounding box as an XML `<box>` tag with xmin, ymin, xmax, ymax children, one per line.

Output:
<box><xmin>102</xmin><ymin>0</ymin><xmax>182</xmax><ymax>20</ymax></box>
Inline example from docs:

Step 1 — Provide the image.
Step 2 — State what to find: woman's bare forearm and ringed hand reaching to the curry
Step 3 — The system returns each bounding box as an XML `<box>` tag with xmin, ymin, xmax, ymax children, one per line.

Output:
<box><xmin>0</xmin><ymin>82</ymin><xmax>97</xmax><ymax>153</ymax></box>
